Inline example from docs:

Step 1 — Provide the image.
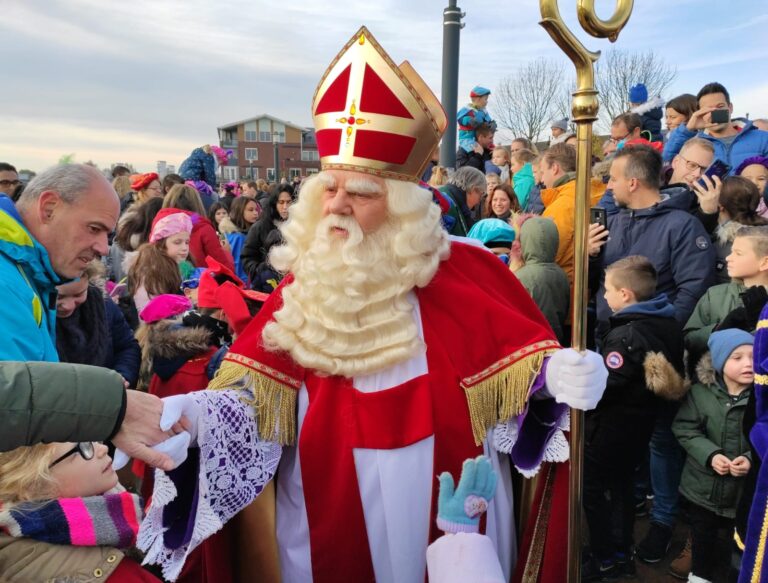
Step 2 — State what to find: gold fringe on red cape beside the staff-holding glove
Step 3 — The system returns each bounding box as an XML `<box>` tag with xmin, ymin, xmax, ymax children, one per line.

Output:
<box><xmin>462</xmin><ymin>350</ymin><xmax>554</xmax><ymax>445</ymax></box>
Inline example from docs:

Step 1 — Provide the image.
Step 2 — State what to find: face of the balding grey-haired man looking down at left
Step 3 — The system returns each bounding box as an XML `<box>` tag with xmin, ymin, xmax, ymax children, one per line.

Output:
<box><xmin>34</xmin><ymin>177</ymin><xmax>120</xmax><ymax>279</ymax></box>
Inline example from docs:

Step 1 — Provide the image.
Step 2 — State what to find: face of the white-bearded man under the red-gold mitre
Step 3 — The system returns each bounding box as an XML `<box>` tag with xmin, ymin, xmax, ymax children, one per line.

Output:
<box><xmin>323</xmin><ymin>170</ymin><xmax>387</xmax><ymax>239</ymax></box>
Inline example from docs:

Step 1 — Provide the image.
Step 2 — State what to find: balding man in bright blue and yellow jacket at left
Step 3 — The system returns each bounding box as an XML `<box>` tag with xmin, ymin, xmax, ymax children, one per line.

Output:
<box><xmin>0</xmin><ymin>164</ymin><xmax>120</xmax><ymax>362</ymax></box>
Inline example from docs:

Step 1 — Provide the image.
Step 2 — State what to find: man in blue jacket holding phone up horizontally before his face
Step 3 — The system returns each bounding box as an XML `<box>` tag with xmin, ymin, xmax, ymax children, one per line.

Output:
<box><xmin>664</xmin><ymin>83</ymin><xmax>768</xmax><ymax>171</ymax></box>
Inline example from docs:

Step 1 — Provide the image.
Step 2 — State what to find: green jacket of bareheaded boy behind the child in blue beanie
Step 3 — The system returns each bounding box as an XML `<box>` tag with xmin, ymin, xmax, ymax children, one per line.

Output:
<box><xmin>683</xmin><ymin>282</ymin><xmax>746</xmax><ymax>364</ymax></box>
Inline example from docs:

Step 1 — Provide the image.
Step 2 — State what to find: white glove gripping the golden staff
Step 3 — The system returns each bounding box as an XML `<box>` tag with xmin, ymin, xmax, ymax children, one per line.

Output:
<box><xmin>547</xmin><ymin>348</ymin><xmax>608</xmax><ymax>411</ymax></box>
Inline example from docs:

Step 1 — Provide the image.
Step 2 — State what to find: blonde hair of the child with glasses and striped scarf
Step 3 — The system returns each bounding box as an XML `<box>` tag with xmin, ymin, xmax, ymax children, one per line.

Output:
<box><xmin>0</xmin><ymin>443</ymin><xmax>56</xmax><ymax>504</ymax></box>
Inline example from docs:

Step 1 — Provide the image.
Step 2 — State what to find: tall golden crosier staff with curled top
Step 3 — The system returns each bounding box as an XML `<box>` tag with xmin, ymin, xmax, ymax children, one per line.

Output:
<box><xmin>539</xmin><ymin>0</ymin><xmax>633</xmax><ymax>583</ymax></box>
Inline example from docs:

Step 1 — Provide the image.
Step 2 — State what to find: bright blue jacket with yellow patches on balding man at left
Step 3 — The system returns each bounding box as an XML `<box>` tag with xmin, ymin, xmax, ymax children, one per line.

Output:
<box><xmin>0</xmin><ymin>195</ymin><xmax>65</xmax><ymax>362</ymax></box>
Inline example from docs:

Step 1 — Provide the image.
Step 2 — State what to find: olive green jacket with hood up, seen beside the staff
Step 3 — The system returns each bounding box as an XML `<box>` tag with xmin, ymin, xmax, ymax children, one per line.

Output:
<box><xmin>515</xmin><ymin>217</ymin><xmax>571</xmax><ymax>343</ymax></box>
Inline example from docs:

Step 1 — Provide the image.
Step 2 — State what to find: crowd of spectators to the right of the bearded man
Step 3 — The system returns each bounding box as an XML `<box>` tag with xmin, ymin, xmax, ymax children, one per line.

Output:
<box><xmin>432</xmin><ymin>83</ymin><xmax>768</xmax><ymax>582</ymax></box>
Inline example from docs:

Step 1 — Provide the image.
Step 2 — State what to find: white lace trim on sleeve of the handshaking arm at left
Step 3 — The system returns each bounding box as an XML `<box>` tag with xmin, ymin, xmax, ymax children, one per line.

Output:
<box><xmin>137</xmin><ymin>390</ymin><xmax>281</xmax><ymax>581</ymax></box>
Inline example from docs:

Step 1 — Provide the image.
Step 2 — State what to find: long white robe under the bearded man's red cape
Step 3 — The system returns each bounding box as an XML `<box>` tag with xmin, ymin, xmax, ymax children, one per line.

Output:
<box><xmin>277</xmin><ymin>294</ymin><xmax>516</xmax><ymax>583</ymax></box>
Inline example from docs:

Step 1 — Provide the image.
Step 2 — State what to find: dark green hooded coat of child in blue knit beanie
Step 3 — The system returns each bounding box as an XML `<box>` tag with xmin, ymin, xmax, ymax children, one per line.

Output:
<box><xmin>672</xmin><ymin>354</ymin><xmax>752</xmax><ymax>518</ymax></box>
